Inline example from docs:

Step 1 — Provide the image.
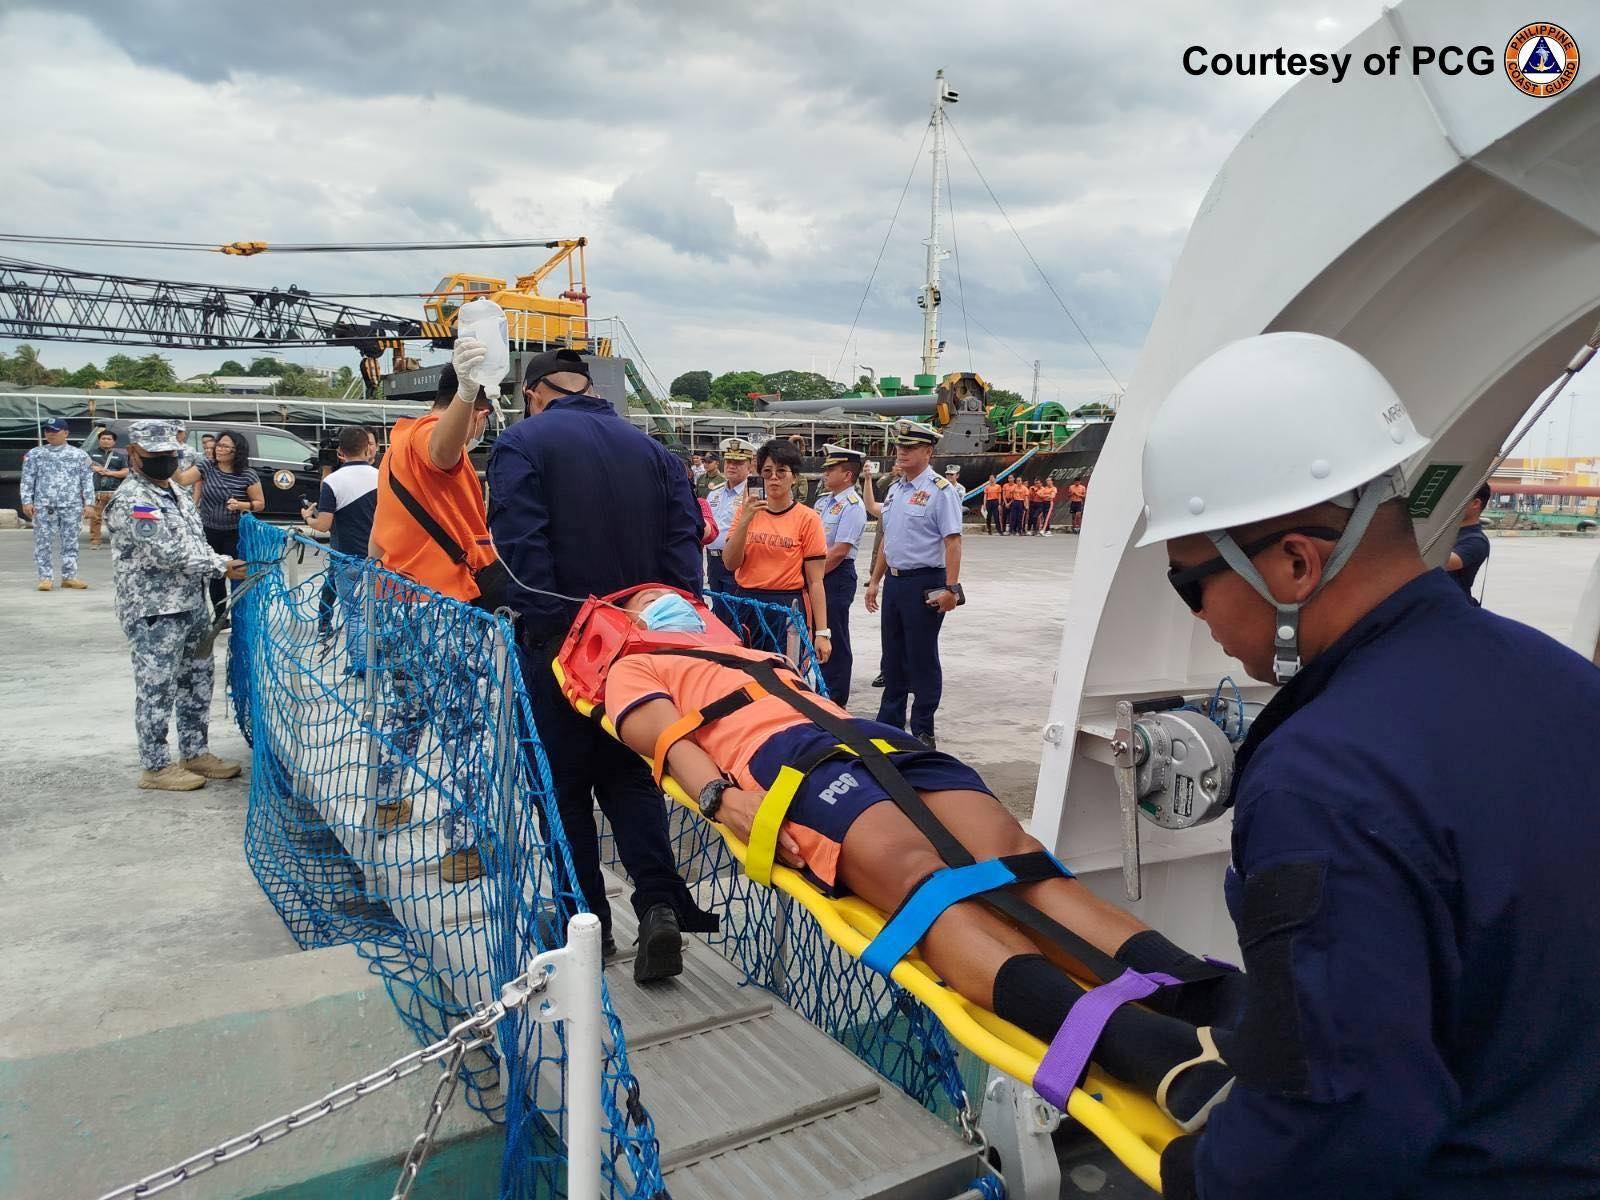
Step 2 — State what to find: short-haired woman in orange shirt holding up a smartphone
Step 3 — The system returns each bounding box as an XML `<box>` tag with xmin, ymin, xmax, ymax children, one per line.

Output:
<box><xmin>722</xmin><ymin>438</ymin><xmax>834</xmax><ymax>662</ymax></box>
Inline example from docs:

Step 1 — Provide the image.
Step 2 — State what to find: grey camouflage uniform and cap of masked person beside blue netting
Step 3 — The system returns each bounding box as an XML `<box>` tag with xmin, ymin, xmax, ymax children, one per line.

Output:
<box><xmin>106</xmin><ymin>421</ymin><xmax>227</xmax><ymax>771</ymax></box>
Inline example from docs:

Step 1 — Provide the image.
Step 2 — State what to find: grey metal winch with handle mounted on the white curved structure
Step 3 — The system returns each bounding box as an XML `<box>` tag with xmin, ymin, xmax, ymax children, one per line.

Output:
<box><xmin>1110</xmin><ymin>696</ymin><xmax>1246</xmax><ymax>901</ymax></box>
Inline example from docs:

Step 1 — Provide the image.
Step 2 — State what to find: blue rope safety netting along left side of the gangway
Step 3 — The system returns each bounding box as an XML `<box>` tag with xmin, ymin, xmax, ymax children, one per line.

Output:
<box><xmin>229</xmin><ymin>518</ymin><xmax>666</xmax><ymax>1200</ymax></box>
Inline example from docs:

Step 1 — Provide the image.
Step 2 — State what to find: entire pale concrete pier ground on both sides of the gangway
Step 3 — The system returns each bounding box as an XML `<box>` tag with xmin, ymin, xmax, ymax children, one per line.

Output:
<box><xmin>0</xmin><ymin>531</ymin><xmax>1600</xmax><ymax>1195</ymax></box>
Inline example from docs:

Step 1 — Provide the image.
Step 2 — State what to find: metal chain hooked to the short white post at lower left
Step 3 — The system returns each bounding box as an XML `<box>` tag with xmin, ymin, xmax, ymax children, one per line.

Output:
<box><xmin>101</xmin><ymin>970</ymin><xmax>550</xmax><ymax>1200</ymax></box>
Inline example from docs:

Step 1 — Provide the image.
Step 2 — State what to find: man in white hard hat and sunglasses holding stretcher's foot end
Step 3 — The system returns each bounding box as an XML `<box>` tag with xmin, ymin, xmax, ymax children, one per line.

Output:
<box><xmin>1139</xmin><ymin>333</ymin><xmax>1600</xmax><ymax>1200</ymax></box>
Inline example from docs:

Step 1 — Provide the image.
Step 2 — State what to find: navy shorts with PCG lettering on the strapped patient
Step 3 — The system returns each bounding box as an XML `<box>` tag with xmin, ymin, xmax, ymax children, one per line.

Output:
<box><xmin>750</xmin><ymin>718</ymin><xmax>994</xmax><ymax>896</ymax></box>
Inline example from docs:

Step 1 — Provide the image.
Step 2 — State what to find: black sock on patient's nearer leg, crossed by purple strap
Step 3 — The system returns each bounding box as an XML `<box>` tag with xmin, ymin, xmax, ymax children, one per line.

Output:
<box><xmin>994</xmin><ymin>954</ymin><xmax>1229</xmax><ymax>1118</ymax></box>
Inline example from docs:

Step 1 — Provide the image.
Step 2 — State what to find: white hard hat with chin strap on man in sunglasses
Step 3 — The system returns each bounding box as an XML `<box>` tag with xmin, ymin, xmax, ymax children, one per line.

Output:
<box><xmin>1138</xmin><ymin>333</ymin><xmax>1427</xmax><ymax>546</ymax></box>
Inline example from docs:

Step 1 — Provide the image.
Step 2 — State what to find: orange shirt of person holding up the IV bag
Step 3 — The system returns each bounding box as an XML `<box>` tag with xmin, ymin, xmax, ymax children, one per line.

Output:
<box><xmin>373</xmin><ymin>411</ymin><xmax>494</xmax><ymax>600</ymax></box>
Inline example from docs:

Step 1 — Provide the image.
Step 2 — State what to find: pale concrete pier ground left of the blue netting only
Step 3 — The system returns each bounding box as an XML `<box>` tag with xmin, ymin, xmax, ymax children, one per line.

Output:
<box><xmin>0</xmin><ymin>531</ymin><xmax>501</xmax><ymax>1200</ymax></box>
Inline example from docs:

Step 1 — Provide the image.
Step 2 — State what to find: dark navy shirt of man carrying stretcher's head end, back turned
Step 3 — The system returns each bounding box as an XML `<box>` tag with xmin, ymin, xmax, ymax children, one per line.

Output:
<box><xmin>488</xmin><ymin>395</ymin><xmax>702</xmax><ymax>643</ymax></box>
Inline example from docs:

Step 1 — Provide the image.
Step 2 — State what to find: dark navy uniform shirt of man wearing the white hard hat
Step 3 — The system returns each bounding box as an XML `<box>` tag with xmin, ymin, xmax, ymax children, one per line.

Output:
<box><xmin>1184</xmin><ymin>571</ymin><xmax>1600</xmax><ymax>1200</ymax></box>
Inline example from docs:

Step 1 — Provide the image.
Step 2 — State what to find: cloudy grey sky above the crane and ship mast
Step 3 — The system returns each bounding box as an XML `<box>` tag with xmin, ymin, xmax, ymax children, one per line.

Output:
<box><xmin>0</xmin><ymin>0</ymin><xmax>1582</xmax><ymax>453</ymax></box>
